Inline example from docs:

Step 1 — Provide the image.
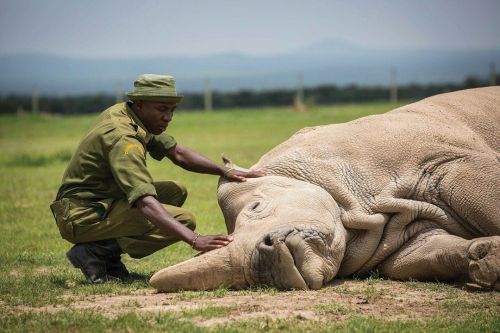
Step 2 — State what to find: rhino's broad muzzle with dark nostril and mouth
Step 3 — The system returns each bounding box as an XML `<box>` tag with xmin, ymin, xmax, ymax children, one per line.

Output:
<box><xmin>247</xmin><ymin>229</ymin><xmax>336</xmax><ymax>289</ymax></box>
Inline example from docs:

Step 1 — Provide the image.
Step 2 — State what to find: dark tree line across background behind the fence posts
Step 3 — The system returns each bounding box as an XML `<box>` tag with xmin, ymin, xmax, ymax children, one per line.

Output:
<box><xmin>0</xmin><ymin>75</ymin><xmax>500</xmax><ymax>114</ymax></box>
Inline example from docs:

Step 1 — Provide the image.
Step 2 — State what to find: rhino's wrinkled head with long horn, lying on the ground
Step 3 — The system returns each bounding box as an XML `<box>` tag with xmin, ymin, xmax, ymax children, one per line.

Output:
<box><xmin>150</xmin><ymin>176</ymin><xmax>346</xmax><ymax>291</ymax></box>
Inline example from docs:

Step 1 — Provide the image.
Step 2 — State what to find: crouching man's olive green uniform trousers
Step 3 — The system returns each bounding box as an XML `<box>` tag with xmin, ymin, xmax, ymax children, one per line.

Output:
<box><xmin>50</xmin><ymin>181</ymin><xmax>196</xmax><ymax>258</ymax></box>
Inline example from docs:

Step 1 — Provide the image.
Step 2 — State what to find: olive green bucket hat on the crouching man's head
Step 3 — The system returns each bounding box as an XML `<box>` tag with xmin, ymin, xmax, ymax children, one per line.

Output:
<box><xmin>127</xmin><ymin>74</ymin><xmax>184</xmax><ymax>103</ymax></box>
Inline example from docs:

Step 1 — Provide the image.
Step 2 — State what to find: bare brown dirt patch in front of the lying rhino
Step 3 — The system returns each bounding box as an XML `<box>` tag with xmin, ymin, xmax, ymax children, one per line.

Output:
<box><xmin>12</xmin><ymin>280</ymin><xmax>500</xmax><ymax>327</ymax></box>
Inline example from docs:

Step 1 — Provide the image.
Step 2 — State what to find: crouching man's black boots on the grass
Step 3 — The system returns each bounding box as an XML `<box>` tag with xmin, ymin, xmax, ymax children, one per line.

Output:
<box><xmin>67</xmin><ymin>239</ymin><xmax>130</xmax><ymax>283</ymax></box>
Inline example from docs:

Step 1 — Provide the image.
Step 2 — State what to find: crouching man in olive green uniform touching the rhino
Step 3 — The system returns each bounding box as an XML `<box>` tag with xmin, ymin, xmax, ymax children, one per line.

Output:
<box><xmin>50</xmin><ymin>74</ymin><xmax>261</xmax><ymax>283</ymax></box>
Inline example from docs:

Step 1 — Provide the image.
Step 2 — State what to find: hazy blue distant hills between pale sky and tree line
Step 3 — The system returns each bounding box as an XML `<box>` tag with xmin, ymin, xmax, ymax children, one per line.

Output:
<box><xmin>0</xmin><ymin>41</ymin><xmax>500</xmax><ymax>95</ymax></box>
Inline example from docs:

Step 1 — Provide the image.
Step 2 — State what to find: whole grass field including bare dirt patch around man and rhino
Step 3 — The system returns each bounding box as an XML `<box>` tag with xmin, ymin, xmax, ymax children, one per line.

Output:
<box><xmin>0</xmin><ymin>103</ymin><xmax>500</xmax><ymax>332</ymax></box>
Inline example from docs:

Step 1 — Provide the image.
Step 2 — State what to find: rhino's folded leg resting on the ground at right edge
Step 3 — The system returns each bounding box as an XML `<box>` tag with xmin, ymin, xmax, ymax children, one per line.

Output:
<box><xmin>379</xmin><ymin>229</ymin><xmax>500</xmax><ymax>290</ymax></box>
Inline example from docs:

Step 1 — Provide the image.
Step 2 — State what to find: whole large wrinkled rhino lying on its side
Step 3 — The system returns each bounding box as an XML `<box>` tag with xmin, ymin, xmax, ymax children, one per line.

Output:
<box><xmin>150</xmin><ymin>86</ymin><xmax>500</xmax><ymax>292</ymax></box>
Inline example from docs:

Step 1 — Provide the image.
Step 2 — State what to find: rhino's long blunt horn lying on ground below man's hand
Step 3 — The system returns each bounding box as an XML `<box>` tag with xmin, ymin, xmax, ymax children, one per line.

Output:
<box><xmin>149</xmin><ymin>244</ymin><xmax>247</xmax><ymax>292</ymax></box>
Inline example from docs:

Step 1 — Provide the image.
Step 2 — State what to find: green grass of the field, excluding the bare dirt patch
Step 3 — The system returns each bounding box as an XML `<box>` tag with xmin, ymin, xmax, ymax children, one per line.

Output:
<box><xmin>0</xmin><ymin>103</ymin><xmax>499</xmax><ymax>332</ymax></box>
